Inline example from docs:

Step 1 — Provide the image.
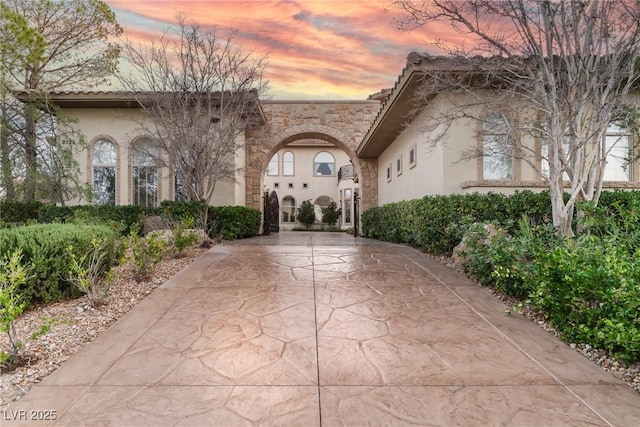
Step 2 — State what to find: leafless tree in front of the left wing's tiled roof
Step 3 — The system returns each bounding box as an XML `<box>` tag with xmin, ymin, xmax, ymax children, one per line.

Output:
<box><xmin>120</xmin><ymin>15</ymin><xmax>267</xmax><ymax>202</ymax></box>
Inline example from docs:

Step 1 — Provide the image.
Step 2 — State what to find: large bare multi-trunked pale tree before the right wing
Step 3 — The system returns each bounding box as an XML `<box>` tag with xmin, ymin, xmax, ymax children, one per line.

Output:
<box><xmin>393</xmin><ymin>0</ymin><xmax>640</xmax><ymax>236</ymax></box>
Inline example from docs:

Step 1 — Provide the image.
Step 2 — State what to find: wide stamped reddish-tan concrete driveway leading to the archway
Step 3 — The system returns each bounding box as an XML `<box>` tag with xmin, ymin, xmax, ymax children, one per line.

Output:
<box><xmin>1</xmin><ymin>233</ymin><xmax>640</xmax><ymax>426</ymax></box>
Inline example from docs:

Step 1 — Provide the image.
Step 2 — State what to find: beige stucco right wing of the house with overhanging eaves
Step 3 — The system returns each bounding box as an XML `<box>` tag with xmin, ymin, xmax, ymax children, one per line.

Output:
<box><xmin>357</xmin><ymin>53</ymin><xmax>640</xmax><ymax>206</ymax></box>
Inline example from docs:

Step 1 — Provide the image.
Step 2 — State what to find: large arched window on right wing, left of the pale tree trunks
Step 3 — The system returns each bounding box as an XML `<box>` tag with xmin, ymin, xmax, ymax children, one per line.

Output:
<box><xmin>482</xmin><ymin>113</ymin><xmax>513</xmax><ymax>179</ymax></box>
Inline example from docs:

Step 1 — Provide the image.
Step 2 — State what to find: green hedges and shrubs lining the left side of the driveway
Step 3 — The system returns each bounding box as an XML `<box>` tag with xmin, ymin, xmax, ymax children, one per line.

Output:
<box><xmin>0</xmin><ymin>202</ymin><xmax>260</xmax><ymax>378</ymax></box>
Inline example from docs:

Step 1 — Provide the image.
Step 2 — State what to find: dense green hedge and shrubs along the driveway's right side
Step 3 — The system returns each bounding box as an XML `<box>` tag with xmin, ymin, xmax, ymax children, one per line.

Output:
<box><xmin>362</xmin><ymin>191</ymin><xmax>640</xmax><ymax>363</ymax></box>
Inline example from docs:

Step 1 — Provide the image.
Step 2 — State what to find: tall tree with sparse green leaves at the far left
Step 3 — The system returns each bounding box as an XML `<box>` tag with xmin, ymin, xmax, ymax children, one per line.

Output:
<box><xmin>0</xmin><ymin>0</ymin><xmax>122</xmax><ymax>201</ymax></box>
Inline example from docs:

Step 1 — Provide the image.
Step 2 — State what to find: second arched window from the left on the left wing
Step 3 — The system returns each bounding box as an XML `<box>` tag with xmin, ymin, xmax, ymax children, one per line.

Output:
<box><xmin>131</xmin><ymin>140</ymin><xmax>158</xmax><ymax>207</ymax></box>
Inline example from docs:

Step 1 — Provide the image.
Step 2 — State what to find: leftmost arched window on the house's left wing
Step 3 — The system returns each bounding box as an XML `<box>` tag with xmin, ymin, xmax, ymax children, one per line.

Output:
<box><xmin>91</xmin><ymin>139</ymin><xmax>117</xmax><ymax>205</ymax></box>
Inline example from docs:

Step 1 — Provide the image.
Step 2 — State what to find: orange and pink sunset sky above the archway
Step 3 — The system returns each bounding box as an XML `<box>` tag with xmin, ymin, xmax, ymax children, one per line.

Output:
<box><xmin>105</xmin><ymin>0</ymin><xmax>444</xmax><ymax>100</ymax></box>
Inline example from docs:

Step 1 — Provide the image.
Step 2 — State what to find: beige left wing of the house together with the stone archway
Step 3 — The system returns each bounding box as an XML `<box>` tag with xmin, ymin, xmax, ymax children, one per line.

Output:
<box><xmin>18</xmin><ymin>92</ymin><xmax>370</xmax><ymax>230</ymax></box>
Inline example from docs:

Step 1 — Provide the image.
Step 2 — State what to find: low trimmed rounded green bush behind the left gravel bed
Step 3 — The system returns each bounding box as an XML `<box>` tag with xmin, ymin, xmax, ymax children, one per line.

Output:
<box><xmin>0</xmin><ymin>224</ymin><xmax>117</xmax><ymax>306</ymax></box>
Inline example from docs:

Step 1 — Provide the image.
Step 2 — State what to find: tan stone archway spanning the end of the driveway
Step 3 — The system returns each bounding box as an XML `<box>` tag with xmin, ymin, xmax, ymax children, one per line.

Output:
<box><xmin>245</xmin><ymin>101</ymin><xmax>380</xmax><ymax>212</ymax></box>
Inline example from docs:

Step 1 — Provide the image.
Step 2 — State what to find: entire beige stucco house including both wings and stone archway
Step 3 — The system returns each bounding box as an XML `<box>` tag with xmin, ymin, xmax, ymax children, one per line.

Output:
<box><xmin>8</xmin><ymin>53</ymin><xmax>640</xmax><ymax>230</ymax></box>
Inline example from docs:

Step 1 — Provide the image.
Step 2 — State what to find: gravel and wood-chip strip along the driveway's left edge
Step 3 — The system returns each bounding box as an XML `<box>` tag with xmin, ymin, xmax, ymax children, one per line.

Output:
<box><xmin>0</xmin><ymin>248</ymin><xmax>206</xmax><ymax>407</ymax></box>
